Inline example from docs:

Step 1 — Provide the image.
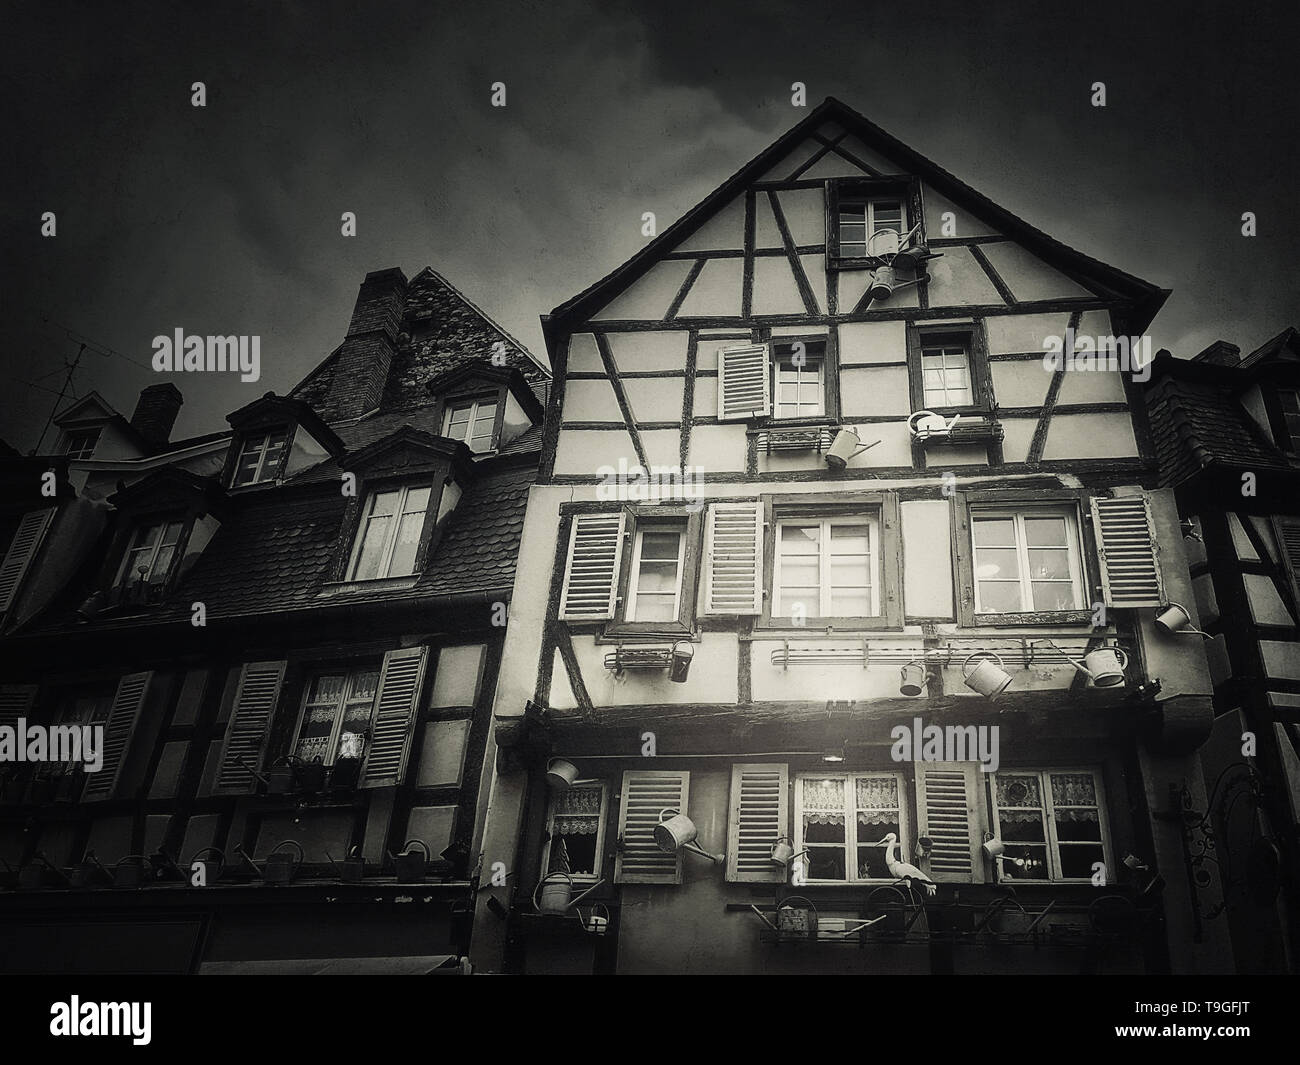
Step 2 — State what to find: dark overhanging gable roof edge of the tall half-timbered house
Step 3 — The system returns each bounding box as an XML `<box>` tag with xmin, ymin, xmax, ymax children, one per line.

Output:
<box><xmin>542</xmin><ymin>96</ymin><xmax>1170</xmax><ymax>332</ymax></box>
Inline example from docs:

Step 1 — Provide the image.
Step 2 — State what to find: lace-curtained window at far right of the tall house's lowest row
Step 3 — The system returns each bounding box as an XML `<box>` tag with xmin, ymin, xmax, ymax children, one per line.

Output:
<box><xmin>992</xmin><ymin>770</ymin><xmax>1110</xmax><ymax>882</ymax></box>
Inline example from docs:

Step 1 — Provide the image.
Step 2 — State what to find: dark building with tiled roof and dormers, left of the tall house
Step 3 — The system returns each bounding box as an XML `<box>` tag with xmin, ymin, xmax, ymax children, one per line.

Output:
<box><xmin>0</xmin><ymin>269</ymin><xmax>549</xmax><ymax>973</ymax></box>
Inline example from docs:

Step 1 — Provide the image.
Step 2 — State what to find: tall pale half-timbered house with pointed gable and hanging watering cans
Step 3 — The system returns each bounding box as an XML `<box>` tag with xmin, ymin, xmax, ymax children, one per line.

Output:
<box><xmin>472</xmin><ymin>100</ymin><xmax>1230</xmax><ymax>975</ymax></box>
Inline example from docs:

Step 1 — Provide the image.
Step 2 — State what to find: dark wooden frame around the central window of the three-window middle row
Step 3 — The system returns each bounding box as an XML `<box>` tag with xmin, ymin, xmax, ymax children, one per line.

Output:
<box><xmin>755</xmin><ymin>492</ymin><xmax>902</xmax><ymax>632</ymax></box>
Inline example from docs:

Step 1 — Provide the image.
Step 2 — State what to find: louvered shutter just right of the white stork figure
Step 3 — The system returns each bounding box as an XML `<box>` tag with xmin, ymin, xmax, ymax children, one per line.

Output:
<box><xmin>904</xmin><ymin>762</ymin><xmax>985</xmax><ymax>884</ymax></box>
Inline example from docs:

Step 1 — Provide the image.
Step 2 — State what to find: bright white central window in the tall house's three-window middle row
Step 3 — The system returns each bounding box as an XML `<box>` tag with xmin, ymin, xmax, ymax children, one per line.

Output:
<box><xmin>772</xmin><ymin>515</ymin><xmax>880</xmax><ymax>619</ymax></box>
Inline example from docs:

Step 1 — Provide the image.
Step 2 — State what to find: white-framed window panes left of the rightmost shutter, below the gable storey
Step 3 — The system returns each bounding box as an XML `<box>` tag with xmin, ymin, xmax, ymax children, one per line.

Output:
<box><xmin>970</xmin><ymin>506</ymin><xmax>1086</xmax><ymax>614</ymax></box>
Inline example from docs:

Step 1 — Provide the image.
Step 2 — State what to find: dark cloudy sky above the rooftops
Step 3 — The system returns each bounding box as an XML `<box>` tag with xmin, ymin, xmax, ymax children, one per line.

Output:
<box><xmin>0</xmin><ymin>0</ymin><xmax>1300</xmax><ymax>451</ymax></box>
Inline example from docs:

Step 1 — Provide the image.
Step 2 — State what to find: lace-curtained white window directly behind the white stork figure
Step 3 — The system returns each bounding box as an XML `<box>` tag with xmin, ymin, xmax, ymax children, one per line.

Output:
<box><xmin>794</xmin><ymin>772</ymin><xmax>911</xmax><ymax>883</ymax></box>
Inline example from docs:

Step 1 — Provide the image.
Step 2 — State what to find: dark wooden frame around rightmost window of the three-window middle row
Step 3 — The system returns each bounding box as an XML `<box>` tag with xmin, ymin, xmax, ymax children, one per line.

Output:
<box><xmin>950</xmin><ymin>489</ymin><xmax>1104</xmax><ymax>627</ymax></box>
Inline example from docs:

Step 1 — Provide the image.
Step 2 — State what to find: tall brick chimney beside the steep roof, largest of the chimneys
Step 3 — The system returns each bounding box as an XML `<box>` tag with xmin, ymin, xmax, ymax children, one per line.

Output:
<box><xmin>324</xmin><ymin>267</ymin><xmax>407</xmax><ymax>421</ymax></box>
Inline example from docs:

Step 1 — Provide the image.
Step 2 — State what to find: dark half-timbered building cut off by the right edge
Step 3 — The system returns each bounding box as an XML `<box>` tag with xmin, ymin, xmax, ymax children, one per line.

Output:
<box><xmin>1147</xmin><ymin>328</ymin><xmax>1300</xmax><ymax>973</ymax></box>
